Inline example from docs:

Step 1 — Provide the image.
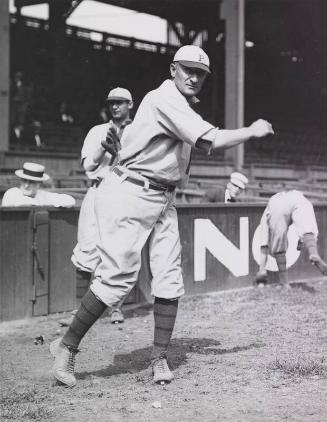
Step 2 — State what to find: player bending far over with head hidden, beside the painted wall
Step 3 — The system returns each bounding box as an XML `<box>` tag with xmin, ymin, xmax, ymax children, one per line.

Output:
<box><xmin>255</xmin><ymin>190</ymin><xmax>327</xmax><ymax>285</ymax></box>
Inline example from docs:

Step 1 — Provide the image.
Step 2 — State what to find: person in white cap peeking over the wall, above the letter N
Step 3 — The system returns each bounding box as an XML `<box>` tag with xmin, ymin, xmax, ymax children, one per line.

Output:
<box><xmin>201</xmin><ymin>171</ymin><xmax>249</xmax><ymax>204</ymax></box>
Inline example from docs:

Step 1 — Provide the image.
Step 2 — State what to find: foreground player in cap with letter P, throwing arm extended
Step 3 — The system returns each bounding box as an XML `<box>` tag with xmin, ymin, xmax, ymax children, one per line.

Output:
<box><xmin>50</xmin><ymin>45</ymin><xmax>273</xmax><ymax>387</ymax></box>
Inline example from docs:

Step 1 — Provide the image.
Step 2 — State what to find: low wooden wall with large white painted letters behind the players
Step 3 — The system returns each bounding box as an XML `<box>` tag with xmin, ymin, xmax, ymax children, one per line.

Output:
<box><xmin>0</xmin><ymin>204</ymin><xmax>327</xmax><ymax>321</ymax></box>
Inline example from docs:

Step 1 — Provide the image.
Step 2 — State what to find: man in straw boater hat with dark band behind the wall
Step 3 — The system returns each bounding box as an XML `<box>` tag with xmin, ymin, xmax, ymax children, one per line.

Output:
<box><xmin>2</xmin><ymin>163</ymin><xmax>75</xmax><ymax>207</ymax></box>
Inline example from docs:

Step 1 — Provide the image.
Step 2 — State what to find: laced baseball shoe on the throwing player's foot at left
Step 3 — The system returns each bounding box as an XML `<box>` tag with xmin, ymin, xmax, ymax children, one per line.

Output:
<box><xmin>50</xmin><ymin>338</ymin><xmax>78</xmax><ymax>387</ymax></box>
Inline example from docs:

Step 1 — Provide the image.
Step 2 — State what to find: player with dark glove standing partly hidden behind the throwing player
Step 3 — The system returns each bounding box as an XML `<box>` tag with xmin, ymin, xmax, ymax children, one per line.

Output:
<box><xmin>71</xmin><ymin>87</ymin><xmax>133</xmax><ymax>325</ymax></box>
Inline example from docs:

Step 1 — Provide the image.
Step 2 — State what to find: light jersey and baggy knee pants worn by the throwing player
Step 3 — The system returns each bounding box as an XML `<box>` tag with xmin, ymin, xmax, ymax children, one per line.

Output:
<box><xmin>91</xmin><ymin>80</ymin><xmax>214</xmax><ymax>306</ymax></box>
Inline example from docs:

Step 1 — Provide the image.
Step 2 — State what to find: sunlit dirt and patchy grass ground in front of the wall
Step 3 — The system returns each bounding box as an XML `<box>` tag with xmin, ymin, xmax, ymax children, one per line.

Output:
<box><xmin>0</xmin><ymin>279</ymin><xmax>327</xmax><ymax>422</ymax></box>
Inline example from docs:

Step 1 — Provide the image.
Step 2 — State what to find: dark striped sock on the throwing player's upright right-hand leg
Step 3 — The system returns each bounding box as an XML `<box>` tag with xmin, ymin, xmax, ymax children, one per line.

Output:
<box><xmin>151</xmin><ymin>297</ymin><xmax>178</xmax><ymax>359</ymax></box>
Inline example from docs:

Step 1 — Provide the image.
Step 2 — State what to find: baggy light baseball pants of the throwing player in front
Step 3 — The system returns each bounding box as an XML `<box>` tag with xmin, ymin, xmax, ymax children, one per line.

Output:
<box><xmin>91</xmin><ymin>167</ymin><xmax>184</xmax><ymax>306</ymax></box>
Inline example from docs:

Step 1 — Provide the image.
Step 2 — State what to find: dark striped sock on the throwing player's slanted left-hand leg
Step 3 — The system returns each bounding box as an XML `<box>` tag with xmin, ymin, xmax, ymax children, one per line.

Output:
<box><xmin>62</xmin><ymin>289</ymin><xmax>107</xmax><ymax>349</ymax></box>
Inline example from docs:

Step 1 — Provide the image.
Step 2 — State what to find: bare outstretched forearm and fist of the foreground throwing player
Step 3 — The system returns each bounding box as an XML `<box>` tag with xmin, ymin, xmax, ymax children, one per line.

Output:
<box><xmin>196</xmin><ymin>119</ymin><xmax>274</xmax><ymax>151</ymax></box>
